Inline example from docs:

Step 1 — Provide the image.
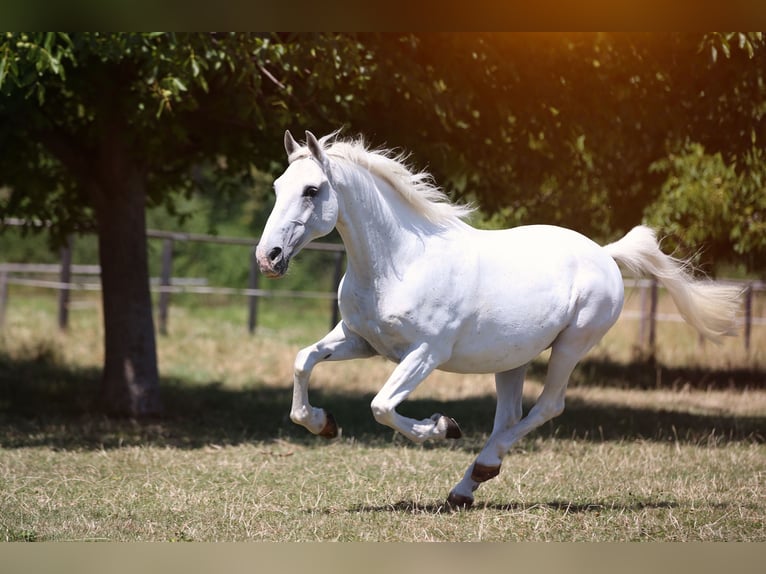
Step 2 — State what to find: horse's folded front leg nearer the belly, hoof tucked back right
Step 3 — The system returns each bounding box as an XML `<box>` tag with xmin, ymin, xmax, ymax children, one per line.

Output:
<box><xmin>370</xmin><ymin>344</ymin><xmax>462</xmax><ymax>443</ymax></box>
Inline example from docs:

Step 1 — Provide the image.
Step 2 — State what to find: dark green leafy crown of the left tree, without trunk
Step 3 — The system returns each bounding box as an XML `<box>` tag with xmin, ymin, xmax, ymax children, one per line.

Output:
<box><xmin>0</xmin><ymin>32</ymin><xmax>372</xmax><ymax>241</ymax></box>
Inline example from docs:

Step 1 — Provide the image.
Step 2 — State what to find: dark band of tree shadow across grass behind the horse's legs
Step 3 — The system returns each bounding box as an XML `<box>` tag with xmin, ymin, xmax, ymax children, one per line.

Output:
<box><xmin>0</xmin><ymin>350</ymin><xmax>766</xmax><ymax>451</ymax></box>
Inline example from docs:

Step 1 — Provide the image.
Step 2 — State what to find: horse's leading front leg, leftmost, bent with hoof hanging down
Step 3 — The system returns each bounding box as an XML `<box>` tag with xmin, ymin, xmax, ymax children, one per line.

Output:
<box><xmin>290</xmin><ymin>321</ymin><xmax>376</xmax><ymax>438</ymax></box>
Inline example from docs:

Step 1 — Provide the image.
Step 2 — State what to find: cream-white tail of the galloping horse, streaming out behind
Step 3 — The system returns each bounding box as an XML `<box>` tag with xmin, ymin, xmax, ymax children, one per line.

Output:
<box><xmin>604</xmin><ymin>225</ymin><xmax>742</xmax><ymax>342</ymax></box>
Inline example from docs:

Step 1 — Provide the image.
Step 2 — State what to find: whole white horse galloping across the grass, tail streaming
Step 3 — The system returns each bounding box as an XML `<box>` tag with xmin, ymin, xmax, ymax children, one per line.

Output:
<box><xmin>255</xmin><ymin>132</ymin><xmax>739</xmax><ymax>507</ymax></box>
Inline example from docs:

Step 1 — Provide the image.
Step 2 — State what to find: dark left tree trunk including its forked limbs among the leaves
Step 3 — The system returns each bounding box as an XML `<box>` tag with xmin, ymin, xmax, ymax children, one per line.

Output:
<box><xmin>39</xmin><ymin>72</ymin><xmax>162</xmax><ymax>418</ymax></box>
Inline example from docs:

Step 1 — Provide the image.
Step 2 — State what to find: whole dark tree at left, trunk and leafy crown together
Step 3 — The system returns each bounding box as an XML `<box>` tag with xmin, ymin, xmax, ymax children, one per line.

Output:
<box><xmin>0</xmin><ymin>33</ymin><xmax>372</xmax><ymax>417</ymax></box>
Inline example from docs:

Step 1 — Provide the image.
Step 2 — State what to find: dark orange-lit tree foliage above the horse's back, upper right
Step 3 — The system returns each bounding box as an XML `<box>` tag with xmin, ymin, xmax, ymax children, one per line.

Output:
<box><xmin>357</xmin><ymin>33</ymin><xmax>766</xmax><ymax>265</ymax></box>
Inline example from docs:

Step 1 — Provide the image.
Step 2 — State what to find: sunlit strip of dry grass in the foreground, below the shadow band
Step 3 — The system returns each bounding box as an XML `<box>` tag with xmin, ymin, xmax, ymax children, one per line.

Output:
<box><xmin>0</xmin><ymin>439</ymin><xmax>766</xmax><ymax>541</ymax></box>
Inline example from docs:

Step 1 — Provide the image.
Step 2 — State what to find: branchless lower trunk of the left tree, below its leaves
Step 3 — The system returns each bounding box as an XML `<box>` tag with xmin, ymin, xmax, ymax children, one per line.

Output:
<box><xmin>93</xmin><ymin>162</ymin><xmax>162</xmax><ymax>417</ymax></box>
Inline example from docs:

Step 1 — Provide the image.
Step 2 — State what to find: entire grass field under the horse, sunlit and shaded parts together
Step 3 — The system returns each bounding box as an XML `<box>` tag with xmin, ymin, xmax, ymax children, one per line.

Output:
<box><xmin>0</xmin><ymin>290</ymin><xmax>766</xmax><ymax>541</ymax></box>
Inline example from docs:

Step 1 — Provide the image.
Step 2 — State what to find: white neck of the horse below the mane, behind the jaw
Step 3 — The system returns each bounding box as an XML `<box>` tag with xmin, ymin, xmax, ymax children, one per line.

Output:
<box><xmin>337</xmin><ymin>168</ymin><xmax>437</xmax><ymax>280</ymax></box>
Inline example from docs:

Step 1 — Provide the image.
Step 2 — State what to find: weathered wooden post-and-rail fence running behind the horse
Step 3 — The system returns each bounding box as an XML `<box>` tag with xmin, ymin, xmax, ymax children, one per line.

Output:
<box><xmin>0</xmin><ymin>230</ymin><xmax>766</xmax><ymax>352</ymax></box>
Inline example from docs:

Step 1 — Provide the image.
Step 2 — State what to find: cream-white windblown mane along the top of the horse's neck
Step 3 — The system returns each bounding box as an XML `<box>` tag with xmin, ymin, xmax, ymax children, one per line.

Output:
<box><xmin>291</xmin><ymin>131</ymin><xmax>475</xmax><ymax>227</ymax></box>
